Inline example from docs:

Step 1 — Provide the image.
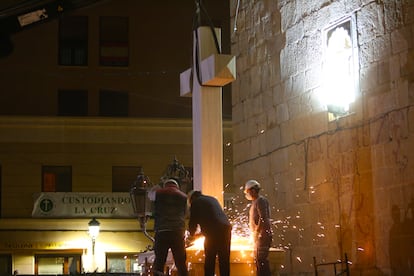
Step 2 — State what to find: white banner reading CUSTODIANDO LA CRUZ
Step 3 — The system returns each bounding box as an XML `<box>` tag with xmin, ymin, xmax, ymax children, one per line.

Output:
<box><xmin>32</xmin><ymin>193</ymin><xmax>135</xmax><ymax>218</ymax></box>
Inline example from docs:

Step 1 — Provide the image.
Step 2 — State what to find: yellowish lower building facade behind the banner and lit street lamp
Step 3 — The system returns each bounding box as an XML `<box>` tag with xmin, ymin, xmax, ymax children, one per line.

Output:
<box><xmin>0</xmin><ymin>117</ymin><xmax>231</xmax><ymax>274</ymax></box>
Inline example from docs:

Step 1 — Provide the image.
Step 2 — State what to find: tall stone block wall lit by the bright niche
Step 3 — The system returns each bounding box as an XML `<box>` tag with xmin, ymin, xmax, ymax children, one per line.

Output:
<box><xmin>230</xmin><ymin>0</ymin><xmax>414</xmax><ymax>275</ymax></box>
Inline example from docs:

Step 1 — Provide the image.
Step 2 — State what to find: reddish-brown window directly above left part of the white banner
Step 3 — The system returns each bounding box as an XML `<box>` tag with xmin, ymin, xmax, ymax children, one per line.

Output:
<box><xmin>42</xmin><ymin>166</ymin><xmax>72</xmax><ymax>192</ymax></box>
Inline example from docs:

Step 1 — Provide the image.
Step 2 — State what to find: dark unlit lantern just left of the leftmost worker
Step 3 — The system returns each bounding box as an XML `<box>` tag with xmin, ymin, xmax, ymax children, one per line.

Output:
<box><xmin>130</xmin><ymin>168</ymin><xmax>154</xmax><ymax>242</ymax></box>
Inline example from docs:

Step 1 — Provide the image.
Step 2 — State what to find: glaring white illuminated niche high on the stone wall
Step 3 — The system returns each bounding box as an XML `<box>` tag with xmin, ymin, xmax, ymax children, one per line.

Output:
<box><xmin>322</xmin><ymin>17</ymin><xmax>358</xmax><ymax>119</ymax></box>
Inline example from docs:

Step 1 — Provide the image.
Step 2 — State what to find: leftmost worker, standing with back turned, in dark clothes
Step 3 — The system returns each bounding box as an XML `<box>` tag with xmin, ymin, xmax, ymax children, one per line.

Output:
<box><xmin>150</xmin><ymin>179</ymin><xmax>188</xmax><ymax>276</ymax></box>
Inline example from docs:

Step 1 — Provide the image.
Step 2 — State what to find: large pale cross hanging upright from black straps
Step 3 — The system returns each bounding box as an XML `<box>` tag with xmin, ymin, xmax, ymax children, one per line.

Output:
<box><xmin>180</xmin><ymin>27</ymin><xmax>236</xmax><ymax>205</ymax></box>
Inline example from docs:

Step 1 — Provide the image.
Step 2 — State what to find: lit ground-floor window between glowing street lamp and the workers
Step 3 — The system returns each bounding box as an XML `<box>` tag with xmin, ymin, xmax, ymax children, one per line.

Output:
<box><xmin>106</xmin><ymin>253</ymin><xmax>143</xmax><ymax>275</ymax></box>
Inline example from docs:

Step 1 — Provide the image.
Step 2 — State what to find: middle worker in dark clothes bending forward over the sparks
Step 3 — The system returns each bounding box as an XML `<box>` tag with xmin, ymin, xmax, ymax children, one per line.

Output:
<box><xmin>188</xmin><ymin>191</ymin><xmax>231</xmax><ymax>276</ymax></box>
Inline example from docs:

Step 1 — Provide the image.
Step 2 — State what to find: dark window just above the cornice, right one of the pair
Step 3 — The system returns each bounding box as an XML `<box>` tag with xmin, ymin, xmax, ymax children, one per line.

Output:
<box><xmin>99</xmin><ymin>90</ymin><xmax>129</xmax><ymax>117</ymax></box>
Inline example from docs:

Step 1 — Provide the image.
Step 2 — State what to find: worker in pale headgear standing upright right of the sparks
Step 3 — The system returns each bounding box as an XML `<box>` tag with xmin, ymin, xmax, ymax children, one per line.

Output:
<box><xmin>244</xmin><ymin>179</ymin><xmax>273</xmax><ymax>276</ymax></box>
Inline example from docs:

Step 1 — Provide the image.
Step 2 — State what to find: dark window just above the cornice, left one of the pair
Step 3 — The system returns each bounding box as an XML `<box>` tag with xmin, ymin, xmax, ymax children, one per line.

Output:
<box><xmin>58</xmin><ymin>90</ymin><xmax>88</xmax><ymax>116</ymax></box>
